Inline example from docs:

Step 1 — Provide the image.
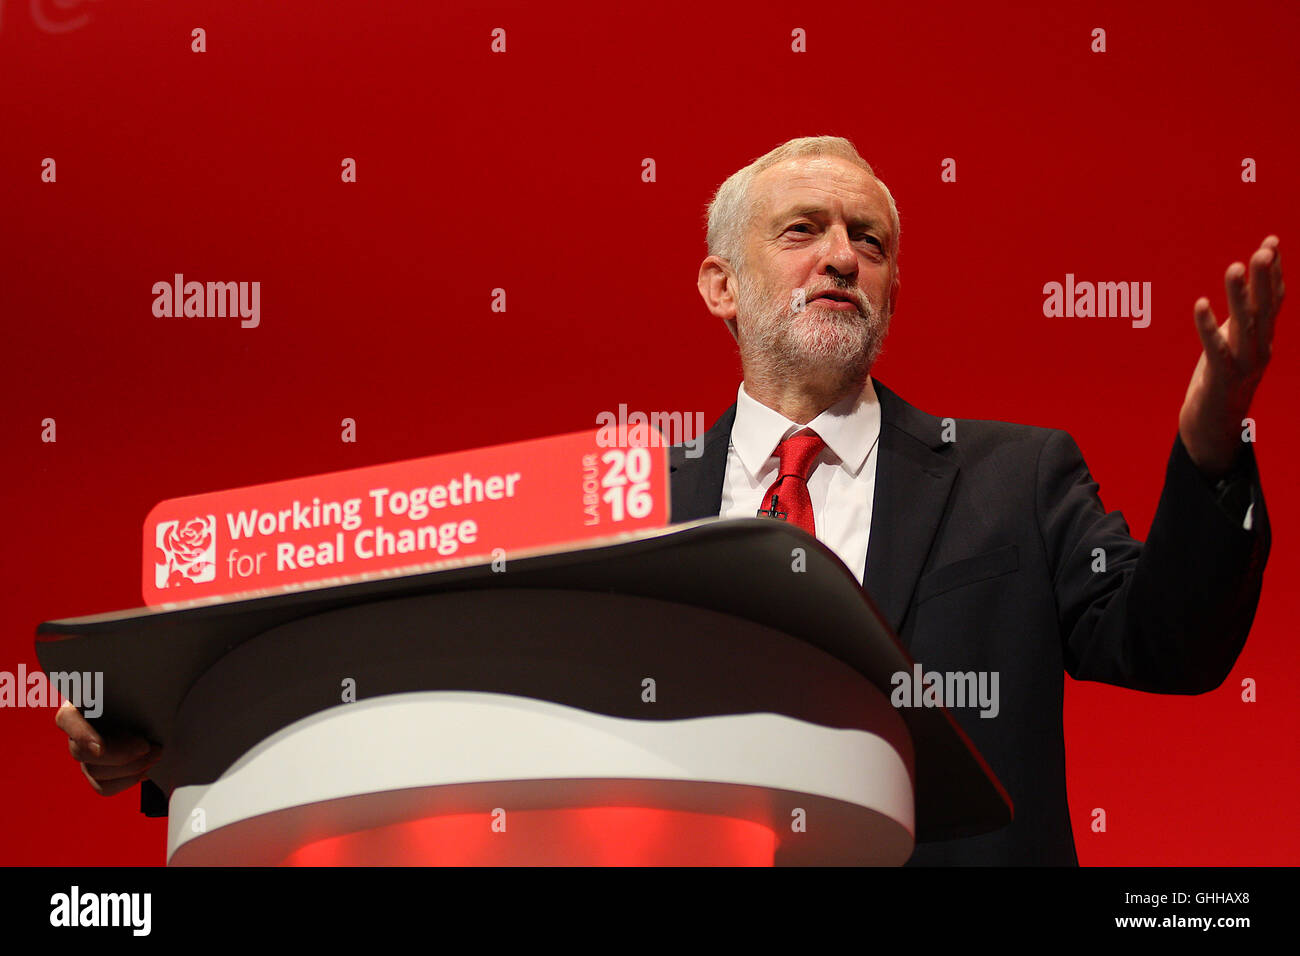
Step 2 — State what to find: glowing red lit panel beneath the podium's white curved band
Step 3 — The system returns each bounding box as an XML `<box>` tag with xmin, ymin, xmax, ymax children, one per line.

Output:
<box><xmin>282</xmin><ymin>806</ymin><xmax>776</xmax><ymax>866</ymax></box>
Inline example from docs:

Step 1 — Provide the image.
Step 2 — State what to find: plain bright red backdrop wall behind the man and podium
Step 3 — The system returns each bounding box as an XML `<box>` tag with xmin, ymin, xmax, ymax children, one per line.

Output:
<box><xmin>0</xmin><ymin>0</ymin><xmax>1300</xmax><ymax>864</ymax></box>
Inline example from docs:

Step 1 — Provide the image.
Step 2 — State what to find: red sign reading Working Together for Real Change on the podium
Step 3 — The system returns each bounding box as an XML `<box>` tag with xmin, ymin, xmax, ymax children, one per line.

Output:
<box><xmin>143</xmin><ymin>432</ymin><xmax>670</xmax><ymax>607</ymax></box>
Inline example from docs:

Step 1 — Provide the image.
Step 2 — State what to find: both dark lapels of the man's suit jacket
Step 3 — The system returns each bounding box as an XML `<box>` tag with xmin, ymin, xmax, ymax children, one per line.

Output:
<box><xmin>668</xmin><ymin>378</ymin><xmax>958</xmax><ymax>642</ymax></box>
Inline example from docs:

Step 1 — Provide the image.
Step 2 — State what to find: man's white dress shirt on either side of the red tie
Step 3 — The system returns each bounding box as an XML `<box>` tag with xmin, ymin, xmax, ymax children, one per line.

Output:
<box><xmin>719</xmin><ymin>376</ymin><xmax>880</xmax><ymax>584</ymax></box>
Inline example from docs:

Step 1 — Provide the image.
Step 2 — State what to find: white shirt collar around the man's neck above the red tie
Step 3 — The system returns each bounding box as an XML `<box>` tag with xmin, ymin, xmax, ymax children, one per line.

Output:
<box><xmin>732</xmin><ymin>376</ymin><xmax>880</xmax><ymax>480</ymax></box>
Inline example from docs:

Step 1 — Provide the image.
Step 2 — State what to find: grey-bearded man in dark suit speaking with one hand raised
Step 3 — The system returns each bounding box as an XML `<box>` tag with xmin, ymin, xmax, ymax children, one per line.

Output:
<box><xmin>671</xmin><ymin>137</ymin><xmax>1283</xmax><ymax>865</ymax></box>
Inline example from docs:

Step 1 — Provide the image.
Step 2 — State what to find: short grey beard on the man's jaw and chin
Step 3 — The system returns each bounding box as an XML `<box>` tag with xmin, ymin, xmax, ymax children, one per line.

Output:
<box><xmin>736</xmin><ymin>282</ymin><xmax>889</xmax><ymax>390</ymax></box>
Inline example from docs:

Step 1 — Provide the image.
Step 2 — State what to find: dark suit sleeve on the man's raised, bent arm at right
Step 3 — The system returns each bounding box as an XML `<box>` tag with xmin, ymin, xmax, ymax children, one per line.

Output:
<box><xmin>1036</xmin><ymin>431</ymin><xmax>1271</xmax><ymax>693</ymax></box>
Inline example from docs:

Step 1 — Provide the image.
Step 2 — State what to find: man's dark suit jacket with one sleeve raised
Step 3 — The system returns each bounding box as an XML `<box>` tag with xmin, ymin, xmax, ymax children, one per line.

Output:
<box><xmin>670</xmin><ymin>380</ymin><xmax>1270</xmax><ymax>865</ymax></box>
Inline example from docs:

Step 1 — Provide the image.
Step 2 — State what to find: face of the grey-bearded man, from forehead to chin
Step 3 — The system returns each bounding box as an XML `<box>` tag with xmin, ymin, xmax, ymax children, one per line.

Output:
<box><xmin>736</xmin><ymin>156</ymin><xmax>897</xmax><ymax>375</ymax></box>
